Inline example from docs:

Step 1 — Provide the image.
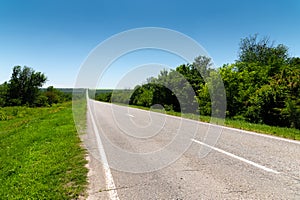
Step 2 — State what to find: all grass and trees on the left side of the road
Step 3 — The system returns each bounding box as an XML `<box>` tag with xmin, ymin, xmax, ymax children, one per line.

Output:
<box><xmin>0</xmin><ymin>66</ymin><xmax>88</xmax><ymax>199</ymax></box>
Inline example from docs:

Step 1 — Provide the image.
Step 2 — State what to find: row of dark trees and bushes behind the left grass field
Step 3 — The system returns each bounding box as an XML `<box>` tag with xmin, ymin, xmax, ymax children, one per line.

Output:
<box><xmin>0</xmin><ymin>66</ymin><xmax>72</xmax><ymax>107</ymax></box>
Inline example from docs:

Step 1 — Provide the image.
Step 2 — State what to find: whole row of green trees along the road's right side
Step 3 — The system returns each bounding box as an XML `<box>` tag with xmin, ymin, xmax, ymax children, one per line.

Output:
<box><xmin>96</xmin><ymin>35</ymin><xmax>300</xmax><ymax>129</ymax></box>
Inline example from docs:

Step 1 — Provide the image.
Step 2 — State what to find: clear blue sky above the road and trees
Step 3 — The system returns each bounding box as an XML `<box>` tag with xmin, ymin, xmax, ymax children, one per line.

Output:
<box><xmin>0</xmin><ymin>0</ymin><xmax>300</xmax><ymax>88</ymax></box>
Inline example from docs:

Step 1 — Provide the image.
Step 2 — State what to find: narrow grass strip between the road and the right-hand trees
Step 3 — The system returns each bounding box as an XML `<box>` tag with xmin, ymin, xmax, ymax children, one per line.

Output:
<box><xmin>114</xmin><ymin>104</ymin><xmax>300</xmax><ymax>140</ymax></box>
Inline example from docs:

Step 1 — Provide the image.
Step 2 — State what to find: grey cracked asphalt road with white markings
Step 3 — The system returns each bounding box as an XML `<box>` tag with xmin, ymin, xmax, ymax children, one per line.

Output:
<box><xmin>84</xmin><ymin>100</ymin><xmax>300</xmax><ymax>200</ymax></box>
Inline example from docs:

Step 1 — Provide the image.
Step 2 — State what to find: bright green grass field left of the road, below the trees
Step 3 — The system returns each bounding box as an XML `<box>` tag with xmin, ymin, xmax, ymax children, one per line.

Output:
<box><xmin>0</xmin><ymin>102</ymin><xmax>87</xmax><ymax>199</ymax></box>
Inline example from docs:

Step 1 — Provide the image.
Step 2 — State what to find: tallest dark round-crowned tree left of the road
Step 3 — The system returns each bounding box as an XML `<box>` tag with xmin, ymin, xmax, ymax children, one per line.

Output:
<box><xmin>7</xmin><ymin>66</ymin><xmax>47</xmax><ymax>106</ymax></box>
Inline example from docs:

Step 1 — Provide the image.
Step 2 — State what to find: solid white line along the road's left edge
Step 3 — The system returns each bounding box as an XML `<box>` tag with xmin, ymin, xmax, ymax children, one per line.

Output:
<box><xmin>87</xmin><ymin>98</ymin><xmax>120</xmax><ymax>200</ymax></box>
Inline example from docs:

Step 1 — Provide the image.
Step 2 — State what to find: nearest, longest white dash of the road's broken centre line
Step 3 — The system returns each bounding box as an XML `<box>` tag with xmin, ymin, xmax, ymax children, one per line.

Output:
<box><xmin>191</xmin><ymin>139</ymin><xmax>280</xmax><ymax>174</ymax></box>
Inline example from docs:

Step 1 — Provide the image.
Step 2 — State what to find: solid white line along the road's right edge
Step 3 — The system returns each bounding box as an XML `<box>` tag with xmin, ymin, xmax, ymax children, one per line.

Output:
<box><xmin>95</xmin><ymin>101</ymin><xmax>300</xmax><ymax>145</ymax></box>
